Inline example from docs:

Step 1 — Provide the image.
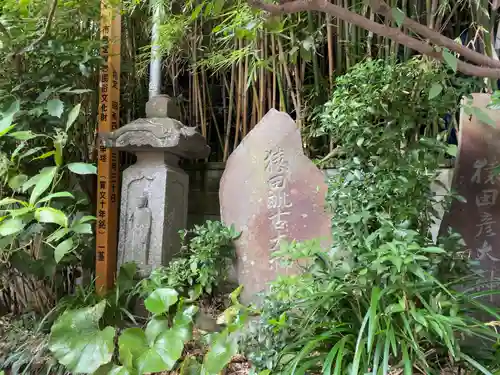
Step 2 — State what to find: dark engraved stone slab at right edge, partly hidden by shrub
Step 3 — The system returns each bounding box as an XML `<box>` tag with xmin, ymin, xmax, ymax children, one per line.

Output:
<box><xmin>440</xmin><ymin>94</ymin><xmax>500</xmax><ymax>306</ymax></box>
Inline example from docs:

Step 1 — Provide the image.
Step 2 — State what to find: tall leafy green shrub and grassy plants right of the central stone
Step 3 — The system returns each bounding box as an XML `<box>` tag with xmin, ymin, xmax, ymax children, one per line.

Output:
<box><xmin>242</xmin><ymin>61</ymin><xmax>499</xmax><ymax>375</ymax></box>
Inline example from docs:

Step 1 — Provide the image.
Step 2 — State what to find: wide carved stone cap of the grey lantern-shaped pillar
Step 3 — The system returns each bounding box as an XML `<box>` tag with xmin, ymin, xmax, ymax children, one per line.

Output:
<box><xmin>101</xmin><ymin>118</ymin><xmax>210</xmax><ymax>159</ymax></box>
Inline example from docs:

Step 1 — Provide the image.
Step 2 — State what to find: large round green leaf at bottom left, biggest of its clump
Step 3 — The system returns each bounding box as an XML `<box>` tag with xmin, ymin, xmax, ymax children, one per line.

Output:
<box><xmin>49</xmin><ymin>300</ymin><xmax>115</xmax><ymax>374</ymax></box>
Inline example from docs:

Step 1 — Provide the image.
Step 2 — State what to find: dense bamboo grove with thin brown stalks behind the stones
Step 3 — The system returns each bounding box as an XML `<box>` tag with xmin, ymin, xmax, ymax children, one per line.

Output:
<box><xmin>4</xmin><ymin>0</ymin><xmax>497</xmax><ymax>165</ymax></box>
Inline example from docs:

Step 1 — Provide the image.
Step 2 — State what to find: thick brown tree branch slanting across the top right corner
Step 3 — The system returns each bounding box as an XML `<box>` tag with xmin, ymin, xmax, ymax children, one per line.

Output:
<box><xmin>249</xmin><ymin>0</ymin><xmax>500</xmax><ymax>79</ymax></box>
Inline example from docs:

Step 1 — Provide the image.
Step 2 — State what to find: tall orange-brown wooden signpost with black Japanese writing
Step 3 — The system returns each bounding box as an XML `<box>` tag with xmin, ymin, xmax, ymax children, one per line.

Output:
<box><xmin>96</xmin><ymin>0</ymin><xmax>121</xmax><ymax>294</ymax></box>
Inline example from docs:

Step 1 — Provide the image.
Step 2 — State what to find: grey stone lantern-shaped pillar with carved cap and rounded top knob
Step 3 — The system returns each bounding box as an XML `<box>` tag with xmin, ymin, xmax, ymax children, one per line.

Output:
<box><xmin>101</xmin><ymin>95</ymin><xmax>210</xmax><ymax>276</ymax></box>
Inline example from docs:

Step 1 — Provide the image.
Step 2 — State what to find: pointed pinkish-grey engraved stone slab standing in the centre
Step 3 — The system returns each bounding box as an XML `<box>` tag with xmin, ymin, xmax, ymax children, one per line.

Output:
<box><xmin>219</xmin><ymin>109</ymin><xmax>331</xmax><ymax>302</ymax></box>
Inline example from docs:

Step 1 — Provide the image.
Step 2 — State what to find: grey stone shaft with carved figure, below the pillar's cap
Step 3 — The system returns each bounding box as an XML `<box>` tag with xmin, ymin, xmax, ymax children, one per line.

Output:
<box><xmin>118</xmin><ymin>152</ymin><xmax>189</xmax><ymax>276</ymax></box>
